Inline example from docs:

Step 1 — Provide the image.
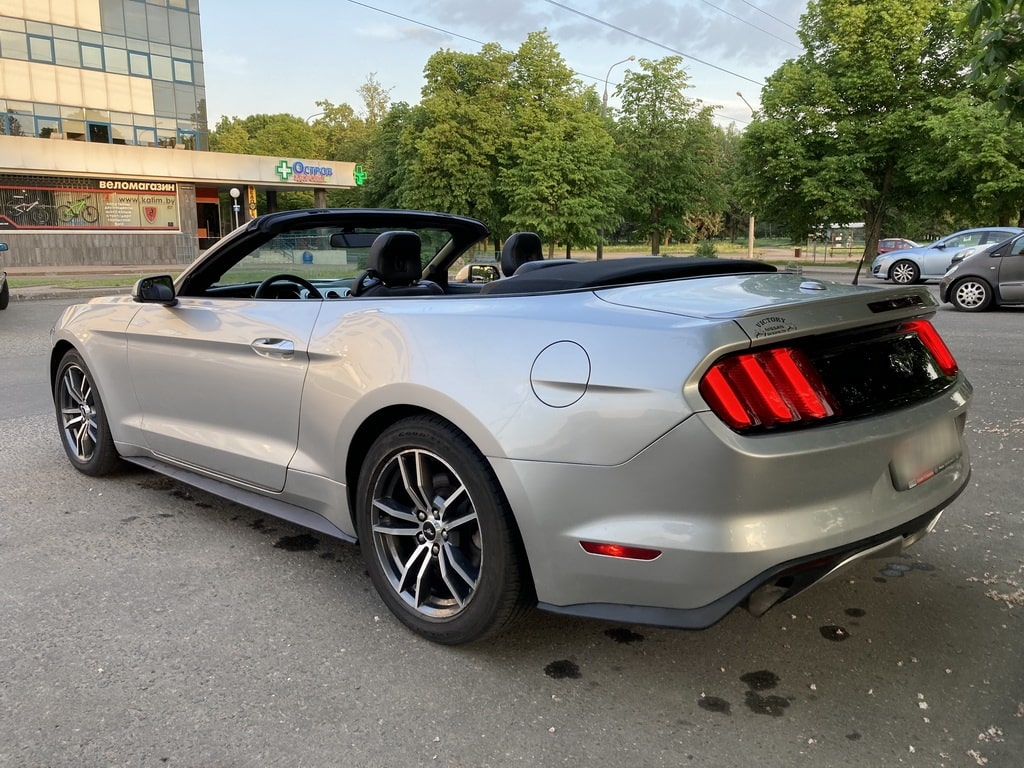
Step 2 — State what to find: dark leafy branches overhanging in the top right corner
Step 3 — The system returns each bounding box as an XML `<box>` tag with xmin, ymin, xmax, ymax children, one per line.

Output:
<box><xmin>967</xmin><ymin>0</ymin><xmax>1024</xmax><ymax>121</ymax></box>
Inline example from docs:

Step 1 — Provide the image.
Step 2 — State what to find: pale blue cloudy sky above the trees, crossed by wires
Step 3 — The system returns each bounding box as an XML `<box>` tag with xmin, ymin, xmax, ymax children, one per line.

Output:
<box><xmin>200</xmin><ymin>0</ymin><xmax>806</xmax><ymax>128</ymax></box>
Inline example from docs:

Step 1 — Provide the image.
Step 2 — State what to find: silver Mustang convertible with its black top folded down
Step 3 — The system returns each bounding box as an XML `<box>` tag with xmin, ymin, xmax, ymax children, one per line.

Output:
<box><xmin>50</xmin><ymin>209</ymin><xmax>971</xmax><ymax>644</ymax></box>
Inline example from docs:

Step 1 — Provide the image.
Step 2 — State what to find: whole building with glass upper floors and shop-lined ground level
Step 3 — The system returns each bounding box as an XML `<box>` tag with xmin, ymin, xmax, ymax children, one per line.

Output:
<box><xmin>0</xmin><ymin>0</ymin><xmax>355</xmax><ymax>266</ymax></box>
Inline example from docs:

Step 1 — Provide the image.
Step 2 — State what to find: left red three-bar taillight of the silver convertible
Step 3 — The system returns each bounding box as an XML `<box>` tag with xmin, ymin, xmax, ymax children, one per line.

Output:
<box><xmin>699</xmin><ymin>347</ymin><xmax>838</xmax><ymax>429</ymax></box>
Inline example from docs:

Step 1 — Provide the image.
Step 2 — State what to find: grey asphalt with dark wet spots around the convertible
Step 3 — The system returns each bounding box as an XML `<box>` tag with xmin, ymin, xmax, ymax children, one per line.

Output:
<box><xmin>0</xmin><ymin>301</ymin><xmax>1024</xmax><ymax>768</ymax></box>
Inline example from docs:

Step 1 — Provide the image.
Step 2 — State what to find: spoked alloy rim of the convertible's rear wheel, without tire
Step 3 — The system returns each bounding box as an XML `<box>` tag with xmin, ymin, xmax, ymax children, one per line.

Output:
<box><xmin>371</xmin><ymin>449</ymin><xmax>483</xmax><ymax>618</ymax></box>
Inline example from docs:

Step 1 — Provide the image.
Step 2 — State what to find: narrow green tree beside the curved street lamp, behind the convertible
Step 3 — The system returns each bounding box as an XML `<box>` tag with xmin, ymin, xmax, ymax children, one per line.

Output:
<box><xmin>615</xmin><ymin>56</ymin><xmax>724</xmax><ymax>255</ymax></box>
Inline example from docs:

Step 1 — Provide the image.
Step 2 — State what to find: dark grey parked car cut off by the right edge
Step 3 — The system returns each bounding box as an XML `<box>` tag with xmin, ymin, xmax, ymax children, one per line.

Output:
<box><xmin>939</xmin><ymin>234</ymin><xmax>1024</xmax><ymax>312</ymax></box>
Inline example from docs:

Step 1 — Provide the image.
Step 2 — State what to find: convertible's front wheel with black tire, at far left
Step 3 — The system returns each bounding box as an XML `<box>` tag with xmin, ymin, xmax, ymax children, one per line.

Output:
<box><xmin>53</xmin><ymin>349</ymin><xmax>121</xmax><ymax>477</ymax></box>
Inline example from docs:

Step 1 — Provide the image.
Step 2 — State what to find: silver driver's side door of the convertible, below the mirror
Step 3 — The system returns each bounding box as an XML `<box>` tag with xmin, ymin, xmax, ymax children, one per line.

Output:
<box><xmin>127</xmin><ymin>297</ymin><xmax>323</xmax><ymax>490</ymax></box>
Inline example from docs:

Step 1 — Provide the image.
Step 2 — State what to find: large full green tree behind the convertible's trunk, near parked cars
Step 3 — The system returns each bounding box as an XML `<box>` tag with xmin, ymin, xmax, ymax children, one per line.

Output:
<box><xmin>742</xmin><ymin>0</ymin><xmax>967</xmax><ymax>256</ymax></box>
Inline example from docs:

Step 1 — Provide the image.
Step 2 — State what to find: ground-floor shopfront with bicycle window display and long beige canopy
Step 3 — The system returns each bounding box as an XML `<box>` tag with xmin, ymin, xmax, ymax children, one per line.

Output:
<box><xmin>0</xmin><ymin>136</ymin><xmax>364</xmax><ymax>266</ymax></box>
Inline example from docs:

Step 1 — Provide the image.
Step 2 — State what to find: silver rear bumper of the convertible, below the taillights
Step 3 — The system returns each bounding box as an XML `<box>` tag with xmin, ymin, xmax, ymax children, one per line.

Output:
<box><xmin>492</xmin><ymin>378</ymin><xmax>971</xmax><ymax>628</ymax></box>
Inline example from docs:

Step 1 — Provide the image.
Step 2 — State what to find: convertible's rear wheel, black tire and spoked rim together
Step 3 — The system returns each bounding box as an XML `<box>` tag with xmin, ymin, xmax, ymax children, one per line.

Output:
<box><xmin>356</xmin><ymin>416</ymin><xmax>532</xmax><ymax>645</ymax></box>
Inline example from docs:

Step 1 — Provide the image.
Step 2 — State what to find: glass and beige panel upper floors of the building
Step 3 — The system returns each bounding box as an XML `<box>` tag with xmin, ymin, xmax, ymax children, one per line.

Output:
<box><xmin>0</xmin><ymin>0</ymin><xmax>209</xmax><ymax>150</ymax></box>
